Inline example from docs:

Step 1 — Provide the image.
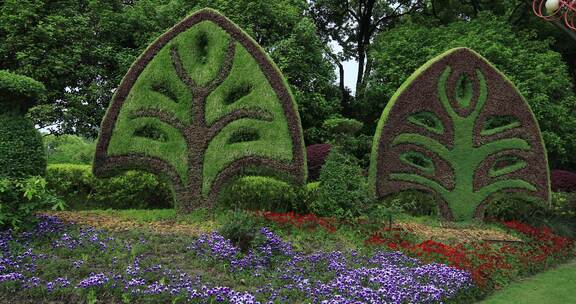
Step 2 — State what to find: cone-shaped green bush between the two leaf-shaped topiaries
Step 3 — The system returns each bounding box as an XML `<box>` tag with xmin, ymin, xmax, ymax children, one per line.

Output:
<box><xmin>310</xmin><ymin>149</ymin><xmax>371</xmax><ymax>218</ymax></box>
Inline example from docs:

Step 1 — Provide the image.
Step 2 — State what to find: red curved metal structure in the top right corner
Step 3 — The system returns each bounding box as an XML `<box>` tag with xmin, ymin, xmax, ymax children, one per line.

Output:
<box><xmin>532</xmin><ymin>0</ymin><xmax>576</xmax><ymax>31</ymax></box>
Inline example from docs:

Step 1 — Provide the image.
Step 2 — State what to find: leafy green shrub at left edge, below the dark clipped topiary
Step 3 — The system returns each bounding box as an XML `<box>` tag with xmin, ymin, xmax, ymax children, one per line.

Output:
<box><xmin>0</xmin><ymin>176</ymin><xmax>65</xmax><ymax>230</ymax></box>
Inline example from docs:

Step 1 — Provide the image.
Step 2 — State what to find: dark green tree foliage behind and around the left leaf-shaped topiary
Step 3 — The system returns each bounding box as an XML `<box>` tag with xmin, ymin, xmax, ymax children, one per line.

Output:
<box><xmin>0</xmin><ymin>0</ymin><xmax>334</xmax><ymax>138</ymax></box>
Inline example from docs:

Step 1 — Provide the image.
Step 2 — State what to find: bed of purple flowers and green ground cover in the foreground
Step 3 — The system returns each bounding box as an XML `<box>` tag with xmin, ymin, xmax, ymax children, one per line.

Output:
<box><xmin>0</xmin><ymin>217</ymin><xmax>474</xmax><ymax>303</ymax></box>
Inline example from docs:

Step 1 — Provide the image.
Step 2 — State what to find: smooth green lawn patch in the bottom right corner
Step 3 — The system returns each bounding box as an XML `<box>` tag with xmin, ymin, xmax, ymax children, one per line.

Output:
<box><xmin>480</xmin><ymin>261</ymin><xmax>576</xmax><ymax>304</ymax></box>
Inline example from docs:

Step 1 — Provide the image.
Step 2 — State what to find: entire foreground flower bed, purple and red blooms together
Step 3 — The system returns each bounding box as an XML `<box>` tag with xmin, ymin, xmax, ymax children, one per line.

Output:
<box><xmin>0</xmin><ymin>213</ymin><xmax>574</xmax><ymax>303</ymax></box>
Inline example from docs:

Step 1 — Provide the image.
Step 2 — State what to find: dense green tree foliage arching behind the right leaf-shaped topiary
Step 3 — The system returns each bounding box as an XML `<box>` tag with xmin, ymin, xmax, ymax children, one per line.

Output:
<box><xmin>366</xmin><ymin>13</ymin><xmax>576</xmax><ymax>168</ymax></box>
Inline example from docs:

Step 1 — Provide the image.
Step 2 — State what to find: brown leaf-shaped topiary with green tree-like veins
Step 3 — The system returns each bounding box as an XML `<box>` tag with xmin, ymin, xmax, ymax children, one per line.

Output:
<box><xmin>370</xmin><ymin>48</ymin><xmax>550</xmax><ymax>220</ymax></box>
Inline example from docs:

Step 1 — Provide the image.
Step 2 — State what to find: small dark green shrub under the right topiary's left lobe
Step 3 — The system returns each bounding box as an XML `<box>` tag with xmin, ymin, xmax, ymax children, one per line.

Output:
<box><xmin>382</xmin><ymin>190</ymin><xmax>438</xmax><ymax>216</ymax></box>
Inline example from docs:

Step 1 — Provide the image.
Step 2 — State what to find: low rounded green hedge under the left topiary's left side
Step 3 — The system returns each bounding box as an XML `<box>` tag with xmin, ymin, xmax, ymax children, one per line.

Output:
<box><xmin>46</xmin><ymin>164</ymin><xmax>172</xmax><ymax>209</ymax></box>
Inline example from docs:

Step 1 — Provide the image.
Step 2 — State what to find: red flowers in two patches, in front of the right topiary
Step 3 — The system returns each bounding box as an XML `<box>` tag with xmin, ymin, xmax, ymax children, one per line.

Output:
<box><xmin>255</xmin><ymin>212</ymin><xmax>574</xmax><ymax>292</ymax></box>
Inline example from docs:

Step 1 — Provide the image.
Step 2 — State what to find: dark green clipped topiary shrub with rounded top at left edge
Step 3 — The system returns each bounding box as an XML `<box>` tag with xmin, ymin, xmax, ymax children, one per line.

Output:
<box><xmin>0</xmin><ymin>70</ymin><xmax>46</xmax><ymax>178</ymax></box>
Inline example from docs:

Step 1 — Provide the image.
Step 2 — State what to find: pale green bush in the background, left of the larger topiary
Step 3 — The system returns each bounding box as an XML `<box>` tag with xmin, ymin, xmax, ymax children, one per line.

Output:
<box><xmin>43</xmin><ymin>134</ymin><xmax>96</xmax><ymax>165</ymax></box>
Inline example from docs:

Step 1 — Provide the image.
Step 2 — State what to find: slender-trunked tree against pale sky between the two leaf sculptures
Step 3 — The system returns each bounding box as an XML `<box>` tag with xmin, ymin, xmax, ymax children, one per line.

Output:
<box><xmin>309</xmin><ymin>0</ymin><xmax>424</xmax><ymax>102</ymax></box>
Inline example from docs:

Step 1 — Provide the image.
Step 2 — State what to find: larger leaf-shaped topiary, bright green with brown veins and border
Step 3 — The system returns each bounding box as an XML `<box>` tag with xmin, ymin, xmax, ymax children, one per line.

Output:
<box><xmin>94</xmin><ymin>9</ymin><xmax>306</xmax><ymax>212</ymax></box>
